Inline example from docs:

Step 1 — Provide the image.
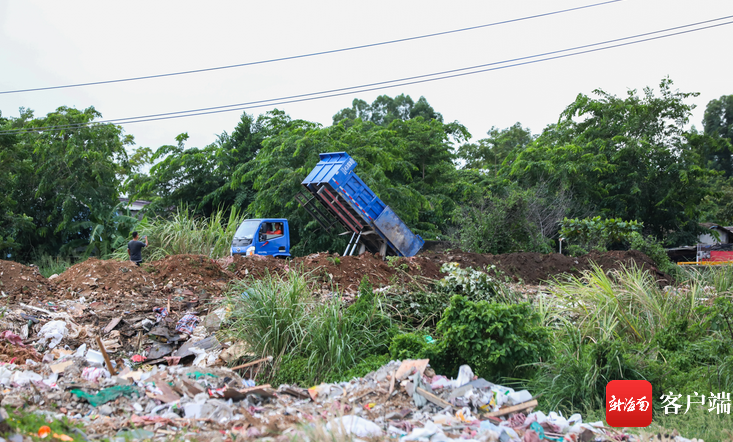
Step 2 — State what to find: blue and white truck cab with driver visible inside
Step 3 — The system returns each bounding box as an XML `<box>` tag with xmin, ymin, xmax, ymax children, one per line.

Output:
<box><xmin>232</xmin><ymin>218</ymin><xmax>290</xmax><ymax>258</ymax></box>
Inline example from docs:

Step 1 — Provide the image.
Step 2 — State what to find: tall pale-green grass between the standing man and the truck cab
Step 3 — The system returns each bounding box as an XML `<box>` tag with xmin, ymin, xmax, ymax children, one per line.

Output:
<box><xmin>112</xmin><ymin>207</ymin><xmax>247</xmax><ymax>261</ymax></box>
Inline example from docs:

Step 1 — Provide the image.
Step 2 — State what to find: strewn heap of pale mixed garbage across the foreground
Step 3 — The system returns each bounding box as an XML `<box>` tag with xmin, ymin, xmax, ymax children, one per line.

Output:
<box><xmin>0</xmin><ymin>322</ymin><xmax>704</xmax><ymax>442</ymax></box>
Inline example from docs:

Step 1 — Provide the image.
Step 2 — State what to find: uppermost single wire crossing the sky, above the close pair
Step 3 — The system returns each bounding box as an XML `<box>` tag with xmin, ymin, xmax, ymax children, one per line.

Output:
<box><xmin>0</xmin><ymin>0</ymin><xmax>623</xmax><ymax>95</ymax></box>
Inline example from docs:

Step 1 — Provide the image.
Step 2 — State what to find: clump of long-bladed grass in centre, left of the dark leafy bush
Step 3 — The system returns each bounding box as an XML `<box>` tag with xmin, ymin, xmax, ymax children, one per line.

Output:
<box><xmin>223</xmin><ymin>270</ymin><xmax>393</xmax><ymax>382</ymax></box>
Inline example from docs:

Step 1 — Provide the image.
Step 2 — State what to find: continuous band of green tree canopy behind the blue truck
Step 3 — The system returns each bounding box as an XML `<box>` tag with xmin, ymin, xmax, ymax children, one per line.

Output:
<box><xmin>0</xmin><ymin>83</ymin><xmax>733</xmax><ymax>260</ymax></box>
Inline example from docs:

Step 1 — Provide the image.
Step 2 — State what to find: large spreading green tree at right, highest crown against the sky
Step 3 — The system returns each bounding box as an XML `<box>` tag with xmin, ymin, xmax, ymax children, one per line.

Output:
<box><xmin>500</xmin><ymin>79</ymin><xmax>714</xmax><ymax>244</ymax></box>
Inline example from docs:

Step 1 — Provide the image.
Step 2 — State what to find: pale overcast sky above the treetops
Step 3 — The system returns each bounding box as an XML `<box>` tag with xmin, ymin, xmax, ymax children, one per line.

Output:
<box><xmin>0</xmin><ymin>0</ymin><xmax>733</xmax><ymax>148</ymax></box>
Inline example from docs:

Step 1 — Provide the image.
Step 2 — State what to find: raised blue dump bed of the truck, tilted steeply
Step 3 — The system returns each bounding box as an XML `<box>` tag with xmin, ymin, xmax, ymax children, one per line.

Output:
<box><xmin>298</xmin><ymin>152</ymin><xmax>425</xmax><ymax>256</ymax></box>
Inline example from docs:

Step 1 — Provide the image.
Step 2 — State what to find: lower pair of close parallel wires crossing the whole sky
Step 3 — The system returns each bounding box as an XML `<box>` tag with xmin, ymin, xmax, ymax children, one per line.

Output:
<box><xmin>0</xmin><ymin>15</ymin><xmax>733</xmax><ymax>135</ymax></box>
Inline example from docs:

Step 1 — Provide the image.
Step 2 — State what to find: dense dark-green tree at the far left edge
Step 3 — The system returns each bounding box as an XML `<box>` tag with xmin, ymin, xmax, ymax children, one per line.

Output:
<box><xmin>3</xmin><ymin>107</ymin><xmax>133</xmax><ymax>260</ymax></box>
